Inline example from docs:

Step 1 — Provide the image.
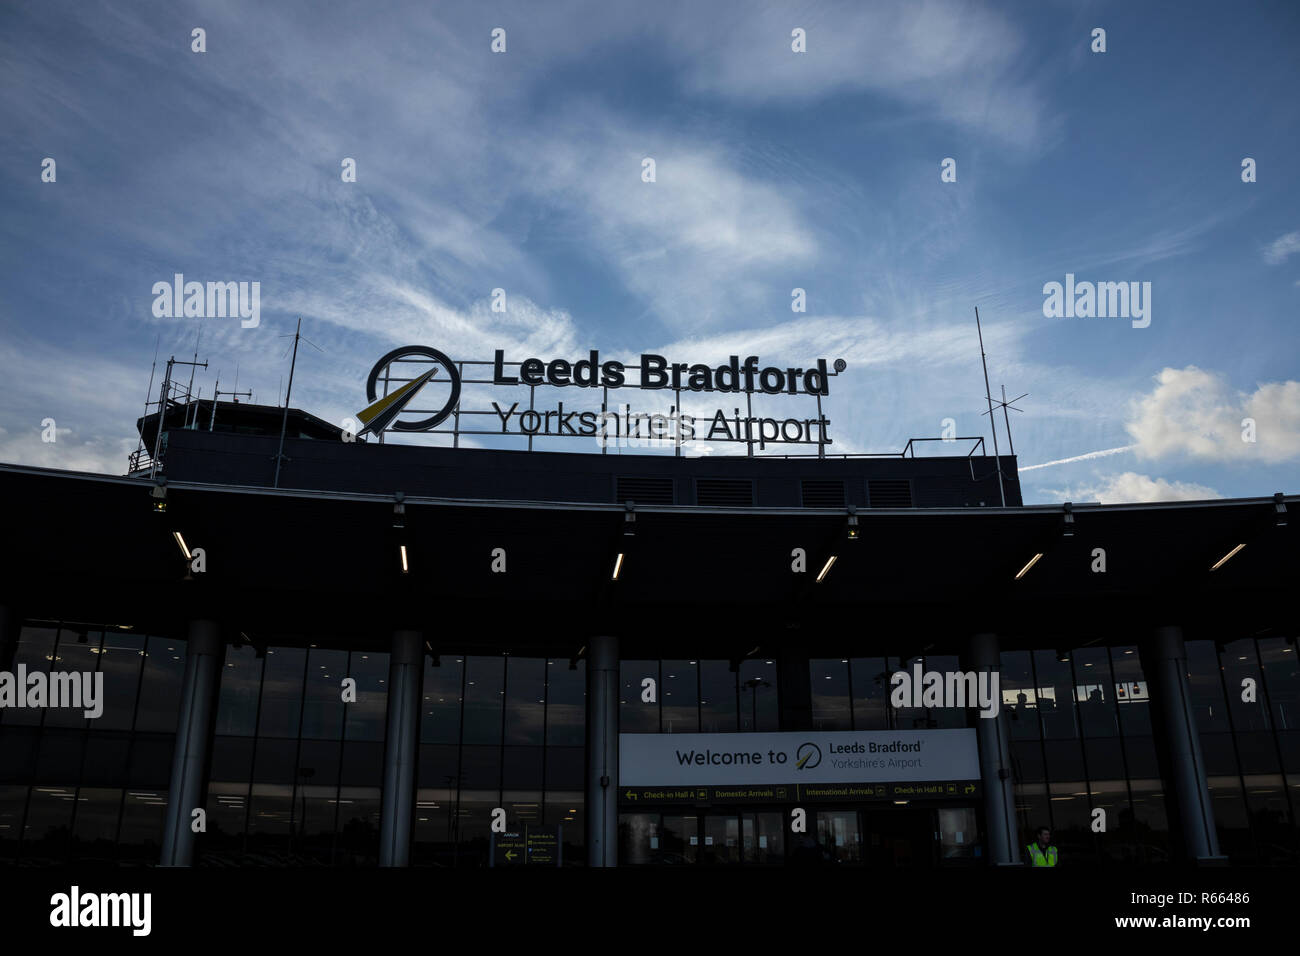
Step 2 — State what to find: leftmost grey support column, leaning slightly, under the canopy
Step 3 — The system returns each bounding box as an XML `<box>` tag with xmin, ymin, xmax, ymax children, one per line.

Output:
<box><xmin>159</xmin><ymin>618</ymin><xmax>224</xmax><ymax>866</ymax></box>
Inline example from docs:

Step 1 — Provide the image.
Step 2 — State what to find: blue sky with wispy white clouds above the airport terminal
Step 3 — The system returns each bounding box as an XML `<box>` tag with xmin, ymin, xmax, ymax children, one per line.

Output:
<box><xmin>0</xmin><ymin>0</ymin><xmax>1300</xmax><ymax>502</ymax></box>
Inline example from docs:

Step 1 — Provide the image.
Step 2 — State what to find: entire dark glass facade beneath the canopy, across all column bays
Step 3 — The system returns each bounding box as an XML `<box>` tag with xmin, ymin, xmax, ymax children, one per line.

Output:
<box><xmin>0</xmin><ymin>620</ymin><xmax>1300</xmax><ymax>866</ymax></box>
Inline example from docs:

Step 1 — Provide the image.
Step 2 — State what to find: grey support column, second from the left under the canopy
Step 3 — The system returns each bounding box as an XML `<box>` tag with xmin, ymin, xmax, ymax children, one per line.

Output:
<box><xmin>380</xmin><ymin>631</ymin><xmax>424</xmax><ymax>866</ymax></box>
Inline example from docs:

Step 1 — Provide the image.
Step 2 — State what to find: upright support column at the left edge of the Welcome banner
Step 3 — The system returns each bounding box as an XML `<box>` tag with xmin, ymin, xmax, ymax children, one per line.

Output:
<box><xmin>586</xmin><ymin>636</ymin><xmax>619</xmax><ymax>866</ymax></box>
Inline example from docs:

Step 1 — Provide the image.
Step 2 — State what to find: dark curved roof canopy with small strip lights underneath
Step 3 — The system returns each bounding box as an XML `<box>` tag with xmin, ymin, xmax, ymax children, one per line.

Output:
<box><xmin>0</xmin><ymin>466</ymin><xmax>1300</xmax><ymax>657</ymax></box>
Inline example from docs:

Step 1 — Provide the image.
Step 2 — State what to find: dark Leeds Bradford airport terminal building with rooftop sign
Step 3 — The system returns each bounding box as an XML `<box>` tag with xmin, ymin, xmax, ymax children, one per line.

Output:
<box><xmin>0</xmin><ymin>350</ymin><xmax>1300</xmax><ymax>868</ymax></box>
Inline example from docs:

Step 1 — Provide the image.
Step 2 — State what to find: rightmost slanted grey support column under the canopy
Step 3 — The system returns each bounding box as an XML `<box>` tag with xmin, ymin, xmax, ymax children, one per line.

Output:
<box><xmin>1143</xmin><ymin>627</ymin><xmax>1225</xmax><ymax>864</ymax></box>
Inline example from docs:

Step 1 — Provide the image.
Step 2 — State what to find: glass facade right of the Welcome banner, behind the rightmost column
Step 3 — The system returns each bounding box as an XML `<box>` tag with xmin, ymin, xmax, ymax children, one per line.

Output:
<box><xmin>1001</xmin><ymin>636</ymin><xmax>1300</xmax><ymax>865</ymax></box>
